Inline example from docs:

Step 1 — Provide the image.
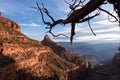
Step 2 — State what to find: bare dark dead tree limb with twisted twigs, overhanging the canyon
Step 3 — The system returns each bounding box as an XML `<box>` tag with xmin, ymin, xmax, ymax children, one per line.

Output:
<box><xmin>36</xmin><ymin>0</ymin><xmax>120</xmax><ymax>42</ymax></box>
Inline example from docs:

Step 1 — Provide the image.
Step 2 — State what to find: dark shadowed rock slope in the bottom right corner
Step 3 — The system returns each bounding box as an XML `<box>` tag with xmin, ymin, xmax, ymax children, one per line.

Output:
<box><xmin>91</xmin><ymin>53</ymin><xmax>120</xmax><ymax>80</ymax></box>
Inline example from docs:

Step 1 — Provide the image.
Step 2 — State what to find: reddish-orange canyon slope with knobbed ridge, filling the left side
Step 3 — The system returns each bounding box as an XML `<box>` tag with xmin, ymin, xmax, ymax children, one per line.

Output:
<box><xmin>0</xmin><ymin>16</ymin><xmax>88</xmax><ymax>80</ymax></box>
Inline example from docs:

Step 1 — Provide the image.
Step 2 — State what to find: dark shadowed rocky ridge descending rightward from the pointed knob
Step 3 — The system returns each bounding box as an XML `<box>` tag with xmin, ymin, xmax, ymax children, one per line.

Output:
<box><xmin>41</xmin><ymin>35</ymin><xmax>88</xmax><ymax>67</ymax></box>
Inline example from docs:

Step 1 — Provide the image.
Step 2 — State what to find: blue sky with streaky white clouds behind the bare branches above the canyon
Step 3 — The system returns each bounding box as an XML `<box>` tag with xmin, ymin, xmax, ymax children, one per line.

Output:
<box><xmin>0</xmin><ymin>0</ymin><xmax>120</xmax><ymax>43</ymax></box>
